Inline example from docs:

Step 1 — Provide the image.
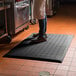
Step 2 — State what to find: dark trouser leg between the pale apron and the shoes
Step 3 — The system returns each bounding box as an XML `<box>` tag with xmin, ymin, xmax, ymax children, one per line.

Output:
<box><xmin>38</xmin><ymin>17</ymin><xmax>47</xmax><ymax>37</ymax></box>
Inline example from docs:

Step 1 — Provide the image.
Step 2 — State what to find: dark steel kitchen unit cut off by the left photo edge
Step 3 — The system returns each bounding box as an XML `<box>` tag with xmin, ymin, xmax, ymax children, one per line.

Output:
<box><xmin>0</xmin><ymin>0</ymin><xmax>11</xmax><ymax>43</ymax></box>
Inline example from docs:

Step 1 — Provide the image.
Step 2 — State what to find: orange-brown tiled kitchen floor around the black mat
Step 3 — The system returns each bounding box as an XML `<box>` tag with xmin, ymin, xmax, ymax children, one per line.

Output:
<box><xmin>0</xmin><ymin>5</ymin><xmax>76</xmax><ymax>76</ymax></box>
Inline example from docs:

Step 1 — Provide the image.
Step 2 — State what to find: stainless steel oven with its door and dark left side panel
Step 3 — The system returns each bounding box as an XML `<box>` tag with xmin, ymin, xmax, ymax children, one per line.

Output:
<box><xmin>8</xmin><ymin>0</ymin><xmax>30</xmax><ymax>35</ymax></box>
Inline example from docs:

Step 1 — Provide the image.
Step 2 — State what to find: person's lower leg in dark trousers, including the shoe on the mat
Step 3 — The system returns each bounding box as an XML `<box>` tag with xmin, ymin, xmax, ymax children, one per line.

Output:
<box><xmin>32</xmin><ymin>17</ymin><xmax>47</xmax><ymax>43</ymax></box>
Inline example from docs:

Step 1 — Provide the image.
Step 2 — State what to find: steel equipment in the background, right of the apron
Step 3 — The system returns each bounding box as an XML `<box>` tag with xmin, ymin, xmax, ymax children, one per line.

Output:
<box><xmin>46</xmin><ymin>0</ymin><xmax>60</xmax><ymax>16</ymax></box>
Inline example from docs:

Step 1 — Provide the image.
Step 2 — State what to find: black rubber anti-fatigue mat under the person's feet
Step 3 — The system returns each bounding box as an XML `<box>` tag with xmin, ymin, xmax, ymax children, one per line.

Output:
<box><xmin>4</xmin><ymin>34</ymin><xmax>73</xmax><ymax>62</ymax></box>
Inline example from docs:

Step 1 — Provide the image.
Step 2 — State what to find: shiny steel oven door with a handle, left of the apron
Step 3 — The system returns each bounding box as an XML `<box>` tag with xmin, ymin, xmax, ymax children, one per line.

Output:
<box><xmin>14</xmin><ymin>3</ymin><xmax>29</xmax><ymax>29</ymax></box>
